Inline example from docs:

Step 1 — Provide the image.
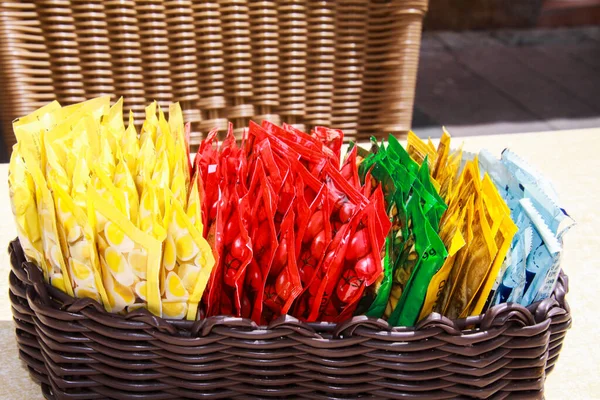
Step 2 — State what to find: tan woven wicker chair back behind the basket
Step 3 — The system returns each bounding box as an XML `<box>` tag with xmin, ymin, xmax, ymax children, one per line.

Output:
<box><xmin>0</xmin><ymin>0</ymin><xmax>427</xmax><ymax>150</ymax></box>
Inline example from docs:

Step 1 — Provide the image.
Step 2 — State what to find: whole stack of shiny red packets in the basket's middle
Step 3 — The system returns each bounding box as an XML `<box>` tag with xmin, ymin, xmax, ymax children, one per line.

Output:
<box><xmin>193</xmin><ymin>121</ymin><xmax>391</xmax><ymax>324</ymax></box>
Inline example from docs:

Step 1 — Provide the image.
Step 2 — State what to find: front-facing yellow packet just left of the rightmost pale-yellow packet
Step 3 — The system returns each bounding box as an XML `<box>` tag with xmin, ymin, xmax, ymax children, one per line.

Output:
<box><xmin>88</xmin><ymin>181</ymin><xmax>164</xmax><ymax>315</ymax></box>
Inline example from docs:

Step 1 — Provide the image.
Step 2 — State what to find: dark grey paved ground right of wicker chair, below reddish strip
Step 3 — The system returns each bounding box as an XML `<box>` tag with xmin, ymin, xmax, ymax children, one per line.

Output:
<box><xmin>413</xmin><ymin>27</ymin><xmax>600</xmax><ymax>137</ymax></box>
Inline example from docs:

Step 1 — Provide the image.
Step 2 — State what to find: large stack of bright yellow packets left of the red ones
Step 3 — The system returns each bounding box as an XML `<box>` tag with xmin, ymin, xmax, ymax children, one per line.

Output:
<box><xmin>9</xmin><ymin>96</ymin><xmax>214</xmax><ymax>319</ymax></box>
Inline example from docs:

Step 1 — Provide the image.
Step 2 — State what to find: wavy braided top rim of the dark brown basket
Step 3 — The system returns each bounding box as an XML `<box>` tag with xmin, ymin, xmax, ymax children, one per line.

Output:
<box><xmin>8</xmin><ymin>238</ymin><xmax>570</xmax><ymax>345</ymax></box>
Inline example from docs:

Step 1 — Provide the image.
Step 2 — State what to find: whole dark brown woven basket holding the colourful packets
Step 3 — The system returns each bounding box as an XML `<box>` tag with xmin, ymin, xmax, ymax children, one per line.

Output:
<box><xmin>9</xmin><ymin>240</ymin><xmax>571</xmax><ymax>400</ymax></box>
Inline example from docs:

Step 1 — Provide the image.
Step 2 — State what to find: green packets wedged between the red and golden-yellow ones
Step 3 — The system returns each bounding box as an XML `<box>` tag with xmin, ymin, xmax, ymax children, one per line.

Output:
<box><xmin>350</xmin><ymin>136</ymin><xmax>447</xmax><ymax>325</ymax></box>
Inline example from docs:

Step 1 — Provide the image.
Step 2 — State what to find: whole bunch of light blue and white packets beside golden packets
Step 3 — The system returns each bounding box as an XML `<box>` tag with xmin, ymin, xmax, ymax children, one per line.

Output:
<box><xmin>474</xmin><ymin>149</ymin><xmax>574</xmax><ymax>306</ymax></box>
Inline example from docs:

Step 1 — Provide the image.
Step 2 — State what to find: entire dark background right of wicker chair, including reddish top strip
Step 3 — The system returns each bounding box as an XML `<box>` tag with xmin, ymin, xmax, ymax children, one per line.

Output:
<box><xmin>412</xmin><ymin>0</ymin><xmax>600</xmax><ymax>136</ymax></box>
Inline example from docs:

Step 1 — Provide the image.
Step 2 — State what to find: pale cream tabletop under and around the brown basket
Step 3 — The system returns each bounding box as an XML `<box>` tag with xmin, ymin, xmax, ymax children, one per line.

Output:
<box><xmin>0</xmin><ymin>128</ymin><xmax>600</xmax><ymax>400</ymax></box>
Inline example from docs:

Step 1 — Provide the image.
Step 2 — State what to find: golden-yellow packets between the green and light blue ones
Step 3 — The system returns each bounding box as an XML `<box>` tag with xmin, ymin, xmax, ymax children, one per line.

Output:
<box><xmin>407</xmin><ymin>130</ymin><xmax>517</xmax><ymax>319</ymax></box>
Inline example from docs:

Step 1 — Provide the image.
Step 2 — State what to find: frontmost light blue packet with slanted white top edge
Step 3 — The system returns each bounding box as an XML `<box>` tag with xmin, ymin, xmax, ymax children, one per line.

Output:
<box><xmin>519</xmin><ymin>198</ymin><xmax>562</xmax><ymax>306</ymax></box>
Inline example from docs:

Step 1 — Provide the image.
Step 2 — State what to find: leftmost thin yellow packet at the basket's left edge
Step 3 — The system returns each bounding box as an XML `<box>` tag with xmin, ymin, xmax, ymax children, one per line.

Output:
<box><xmin>8</xmin><ymin>143</ymin><xmax>47</xmax><ymax>277</ymax></box>
